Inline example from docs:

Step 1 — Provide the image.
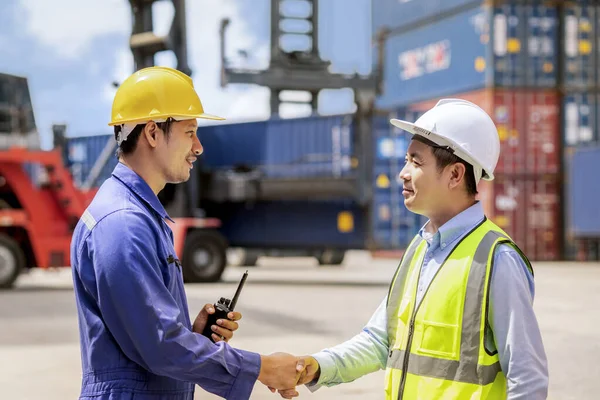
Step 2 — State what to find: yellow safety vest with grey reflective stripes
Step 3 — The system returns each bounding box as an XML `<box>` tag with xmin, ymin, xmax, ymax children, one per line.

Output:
<box><xmin>385</xmin><ymin>218</ymin><xmax>533</xmax><ymax>400</ymax></box>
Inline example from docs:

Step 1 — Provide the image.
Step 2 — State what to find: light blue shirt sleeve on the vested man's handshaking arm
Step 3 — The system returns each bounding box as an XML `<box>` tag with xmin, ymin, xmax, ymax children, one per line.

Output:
<box><xmin>307</xmin><ymin>297</ymin><xmax>388</xmax><ymax>392</ymax></box>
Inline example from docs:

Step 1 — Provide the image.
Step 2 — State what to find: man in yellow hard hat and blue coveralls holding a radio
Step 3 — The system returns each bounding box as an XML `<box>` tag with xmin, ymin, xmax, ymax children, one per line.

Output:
<box><xmin>71</xmin><ymin>67</ymin><xmax>302</xmax><ymax>400</ymax></box>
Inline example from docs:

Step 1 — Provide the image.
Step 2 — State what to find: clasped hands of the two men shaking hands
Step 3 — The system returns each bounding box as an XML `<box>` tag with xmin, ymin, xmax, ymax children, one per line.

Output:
<box><xmin>258</xmin><ymin>353</ymin><xmax>320</xmax><ymax>399</ymax></box>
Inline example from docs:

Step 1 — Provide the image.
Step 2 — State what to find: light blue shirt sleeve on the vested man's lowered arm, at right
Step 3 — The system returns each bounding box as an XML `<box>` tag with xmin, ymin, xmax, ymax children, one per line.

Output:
<box><xmin>486</xmin><ymin>244</ymin><xmax>548</xmax><ymax>400</ymax></box>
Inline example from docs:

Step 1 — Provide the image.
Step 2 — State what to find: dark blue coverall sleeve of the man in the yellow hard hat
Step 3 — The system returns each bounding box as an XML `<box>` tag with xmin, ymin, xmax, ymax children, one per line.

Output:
<box><xmin>87</xmin><ymin>210</ymin><xmax>260</xmax><ymax>399</ymax></box>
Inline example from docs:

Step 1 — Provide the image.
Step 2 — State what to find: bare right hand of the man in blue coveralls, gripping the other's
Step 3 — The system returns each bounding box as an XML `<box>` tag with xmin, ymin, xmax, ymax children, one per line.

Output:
<box><xmin>258</xmin><ymin>353</ymin><xmax>304</xmax><ymax>390</ymax></box>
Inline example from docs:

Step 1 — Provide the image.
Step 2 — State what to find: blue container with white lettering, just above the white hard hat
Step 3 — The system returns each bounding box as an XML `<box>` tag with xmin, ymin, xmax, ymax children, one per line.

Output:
<box><xmin>376</xmin><ymin>4</ymin><xmax>558</xmax><ymax>109</ymax></box>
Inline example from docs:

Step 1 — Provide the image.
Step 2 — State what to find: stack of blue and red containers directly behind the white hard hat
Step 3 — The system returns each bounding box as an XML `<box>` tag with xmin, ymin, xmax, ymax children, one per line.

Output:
<box><xmin>373</xmin><ymin>0</ymin><xmax>562</xmax><ymax>260</ymax></box>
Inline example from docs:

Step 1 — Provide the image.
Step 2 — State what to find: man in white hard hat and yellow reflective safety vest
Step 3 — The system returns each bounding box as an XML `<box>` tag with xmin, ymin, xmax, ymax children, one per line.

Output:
<box><xmin>272</xmin><ymin>99</ymin><xmax>548</xmax><ymax>400</ymax></box>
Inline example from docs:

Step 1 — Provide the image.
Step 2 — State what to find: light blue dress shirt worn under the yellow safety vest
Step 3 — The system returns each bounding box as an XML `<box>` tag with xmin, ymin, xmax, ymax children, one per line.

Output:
<box><xmin>307</xmin><ymin>202</ymin><xmax>548</xmax><ymax>400</ymax></box>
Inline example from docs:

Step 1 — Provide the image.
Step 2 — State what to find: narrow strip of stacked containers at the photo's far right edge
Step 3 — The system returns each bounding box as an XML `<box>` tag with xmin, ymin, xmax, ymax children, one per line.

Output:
<box><xmin>562</xmin><ymin>0</ymin><xmax>600</xmax><ymax>261</ymax></box>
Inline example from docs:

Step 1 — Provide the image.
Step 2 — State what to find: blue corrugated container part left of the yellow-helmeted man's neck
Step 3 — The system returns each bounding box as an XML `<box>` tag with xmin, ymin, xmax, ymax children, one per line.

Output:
<box><xmin>66</xmin><ymin>135</ymin><xmax>118</xmax><ymax>186</ymax></box>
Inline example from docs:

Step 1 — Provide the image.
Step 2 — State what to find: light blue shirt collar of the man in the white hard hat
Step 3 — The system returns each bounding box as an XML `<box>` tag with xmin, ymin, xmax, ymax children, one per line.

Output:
<box><xmin>419</xmin><ymin>201</ymin><xmax>485</xmax><ymax>250</ymax></box>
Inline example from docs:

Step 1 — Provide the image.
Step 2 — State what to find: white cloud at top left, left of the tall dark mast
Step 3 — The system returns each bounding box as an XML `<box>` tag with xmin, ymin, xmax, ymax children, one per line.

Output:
<box><xmin>21</xmin><ymin>0</ymin><xmax>131</xmax><ymax>58</ymax></box>
